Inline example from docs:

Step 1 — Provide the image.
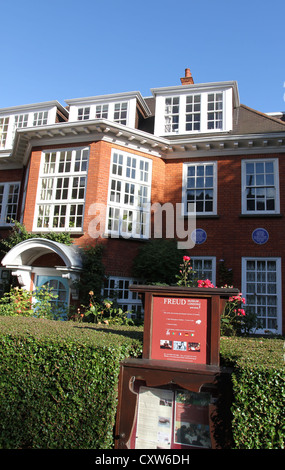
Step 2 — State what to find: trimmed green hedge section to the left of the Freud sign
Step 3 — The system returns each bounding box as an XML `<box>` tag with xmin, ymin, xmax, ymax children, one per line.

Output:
<box><xmin>0</xmin><ymin>317</ymin><xmax>142</xmax><ymax>449</ymax></box>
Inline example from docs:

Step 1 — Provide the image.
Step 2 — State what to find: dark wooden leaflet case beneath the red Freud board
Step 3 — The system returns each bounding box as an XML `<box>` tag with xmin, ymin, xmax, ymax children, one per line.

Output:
<box><xmin>115</xmin><ymin>359</ymin><xmax>232</xmax><ymax>450</ymax></box>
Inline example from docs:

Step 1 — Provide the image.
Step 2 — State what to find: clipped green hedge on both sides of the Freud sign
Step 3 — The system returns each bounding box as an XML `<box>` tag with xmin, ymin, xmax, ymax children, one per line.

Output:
<box><xmin>0</xmin><ymin>317</ymin><xmax>285</xmax><ymax>449</ymax></box>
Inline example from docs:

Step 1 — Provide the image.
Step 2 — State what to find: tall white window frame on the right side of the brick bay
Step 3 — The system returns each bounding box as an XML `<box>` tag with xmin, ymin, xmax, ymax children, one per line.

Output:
<box><xmin>105</xmin><ymin>149</ymin><xmax>152</xmax><ymax>239</ymax></box>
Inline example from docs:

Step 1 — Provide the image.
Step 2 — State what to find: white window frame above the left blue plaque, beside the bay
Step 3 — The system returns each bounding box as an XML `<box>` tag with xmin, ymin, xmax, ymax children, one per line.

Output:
<box><xmin>182</xmin><ymin>161</ymin><xmax>218</xmax><ymax>217</ymax></box>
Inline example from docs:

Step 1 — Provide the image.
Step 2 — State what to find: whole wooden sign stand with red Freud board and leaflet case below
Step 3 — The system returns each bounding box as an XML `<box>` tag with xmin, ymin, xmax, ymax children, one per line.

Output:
<box><xmin>115</xmin><ymin>285</ymin><xmax>238</xmax><ymax>449</ymax></box>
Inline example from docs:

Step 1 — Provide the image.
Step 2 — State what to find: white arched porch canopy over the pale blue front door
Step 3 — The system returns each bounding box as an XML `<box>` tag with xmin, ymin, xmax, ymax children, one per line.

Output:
<box><xmin>2</xmin><ymin>238</ymin><xmax>82</xmax><ymax>290</ymax></box>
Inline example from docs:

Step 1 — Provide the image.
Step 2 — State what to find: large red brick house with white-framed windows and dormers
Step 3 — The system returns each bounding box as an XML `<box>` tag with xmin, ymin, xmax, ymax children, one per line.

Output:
<box><xmin>0</xmin><ymin>69</ymin><xmax>285</xmax><ymax>334</ymax></box>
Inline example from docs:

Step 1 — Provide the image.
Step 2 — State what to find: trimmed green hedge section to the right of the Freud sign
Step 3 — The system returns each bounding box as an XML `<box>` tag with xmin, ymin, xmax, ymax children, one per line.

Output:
<box><xmin>221</xmin><ymin>338</ymin><xmax>285</xmax><ymax>449</ymax></box>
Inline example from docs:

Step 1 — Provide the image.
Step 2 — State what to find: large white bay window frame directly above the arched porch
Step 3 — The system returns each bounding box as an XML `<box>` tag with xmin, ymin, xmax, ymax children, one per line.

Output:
<box><xmin>33</xmin><ymin>146</ymin><xmax>89</xmax><ymax>233</ymax></box>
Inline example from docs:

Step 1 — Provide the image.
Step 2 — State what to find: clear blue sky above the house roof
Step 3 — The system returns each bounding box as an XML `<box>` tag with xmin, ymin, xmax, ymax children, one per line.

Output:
<box><xmin>0</xmin><ymin>0</ymin><xmax>285</xmax><ymax>112</ymax></box>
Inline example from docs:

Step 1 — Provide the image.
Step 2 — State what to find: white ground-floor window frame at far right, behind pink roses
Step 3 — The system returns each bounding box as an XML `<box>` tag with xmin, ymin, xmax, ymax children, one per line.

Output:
<box><xmin>242</xmin><ymin>256</ymin><xmax>282</xmax><ymax>334</ymax></box>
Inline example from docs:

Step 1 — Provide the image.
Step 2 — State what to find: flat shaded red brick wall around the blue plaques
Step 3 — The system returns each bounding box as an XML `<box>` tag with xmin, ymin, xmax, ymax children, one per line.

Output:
<box><xmin>165</xmin><ymin>154</ymin><xmax>285</xmax><ymax>299</ymax></box>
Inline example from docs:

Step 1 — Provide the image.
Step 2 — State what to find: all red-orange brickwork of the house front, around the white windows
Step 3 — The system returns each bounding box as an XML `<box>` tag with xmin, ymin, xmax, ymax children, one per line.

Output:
<box><xmin>5</xmin><ymin>141</ymin><xmax>285</xmax><ymax>332</ymax></box>
